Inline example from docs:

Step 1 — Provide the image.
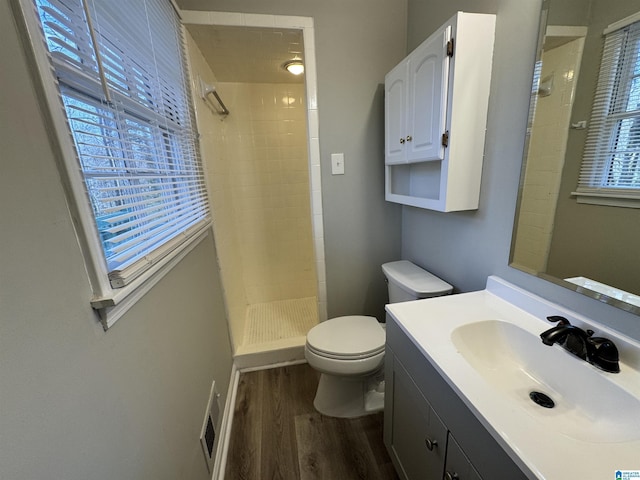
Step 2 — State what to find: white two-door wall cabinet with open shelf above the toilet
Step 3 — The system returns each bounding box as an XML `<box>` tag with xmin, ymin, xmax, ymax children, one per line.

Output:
<box><xmin>385</xmin><ymin>12</ymin><xmax>495</xmax><ymax>212</ymax></box>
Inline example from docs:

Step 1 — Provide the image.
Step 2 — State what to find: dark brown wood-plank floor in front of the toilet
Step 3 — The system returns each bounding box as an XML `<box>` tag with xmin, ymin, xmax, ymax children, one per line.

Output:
<box><xmin>225</xmin><ymin>364</ymin><xmax>398</xmax><ymax>480</ymax></box>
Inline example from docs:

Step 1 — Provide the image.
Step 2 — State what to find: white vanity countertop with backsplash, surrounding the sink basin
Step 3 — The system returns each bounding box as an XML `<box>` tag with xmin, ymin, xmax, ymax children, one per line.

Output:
<box><xmin>387</xmin><ymin>277</ymin><xmax>640</xmax><ymax>480</ymax></box>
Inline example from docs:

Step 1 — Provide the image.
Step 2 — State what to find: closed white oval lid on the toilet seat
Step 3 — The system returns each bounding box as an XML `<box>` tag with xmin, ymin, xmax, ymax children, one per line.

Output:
<box><xmin>307</xmin><ymin>315</ymin><xmax>386</xmax><ymax>357</ymax></box>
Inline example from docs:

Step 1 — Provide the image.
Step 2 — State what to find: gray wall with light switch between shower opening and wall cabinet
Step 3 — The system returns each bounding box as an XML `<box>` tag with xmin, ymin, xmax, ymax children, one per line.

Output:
<box><xmin>178</xmin><ymin>0</ymin><xmax>406</xmax><ymax>318</ymax></box>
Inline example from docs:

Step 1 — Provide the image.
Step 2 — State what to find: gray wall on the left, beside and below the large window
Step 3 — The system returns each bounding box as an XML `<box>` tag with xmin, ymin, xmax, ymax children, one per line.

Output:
<box><xmin>0</xmin><ymin>0</ymin><xmax>231</xmax><ymax>480</ymax></box>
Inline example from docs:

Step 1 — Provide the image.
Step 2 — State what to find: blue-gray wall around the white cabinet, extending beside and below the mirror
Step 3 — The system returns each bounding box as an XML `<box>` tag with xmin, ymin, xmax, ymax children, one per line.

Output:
<box><xmin>402</xmin><ymin>0</ymin><xmax>640</xmax><ymax>338</ymax></box>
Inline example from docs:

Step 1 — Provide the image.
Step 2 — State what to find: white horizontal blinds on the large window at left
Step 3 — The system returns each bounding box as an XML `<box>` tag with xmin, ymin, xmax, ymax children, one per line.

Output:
<box><xmin>36</xmin><ymin>0</ymin><xmax>208</xmax><ymax>288</ymax></box>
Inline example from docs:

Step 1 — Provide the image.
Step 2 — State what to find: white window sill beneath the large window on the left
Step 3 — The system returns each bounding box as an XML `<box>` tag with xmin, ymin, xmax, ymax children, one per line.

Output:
<box><xmin>91</xmin><ymin>224</ymin><xmax>210</xmax><ymax>331</ymax></box>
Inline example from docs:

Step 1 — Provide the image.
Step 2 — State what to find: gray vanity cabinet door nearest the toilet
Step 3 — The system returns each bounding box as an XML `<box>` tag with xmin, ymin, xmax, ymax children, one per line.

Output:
<box><xmin>391</xmin><ymin>362</ymin><xmax>447</xmax><ymax>480</ymax></box>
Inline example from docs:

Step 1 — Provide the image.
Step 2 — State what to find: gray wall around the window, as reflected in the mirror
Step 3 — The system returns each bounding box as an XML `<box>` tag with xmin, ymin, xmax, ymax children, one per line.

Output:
<box><xmin>547</xmin><ymin>0</ymin><xmax>640</xmax><ymax>293</ymax></box>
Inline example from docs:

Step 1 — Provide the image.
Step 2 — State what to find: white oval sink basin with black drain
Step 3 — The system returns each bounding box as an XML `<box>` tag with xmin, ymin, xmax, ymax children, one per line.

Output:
<box><xmin>451</xmin><ymin>320</ymin><xmax>640</xmax><ymax>443</ymax></box>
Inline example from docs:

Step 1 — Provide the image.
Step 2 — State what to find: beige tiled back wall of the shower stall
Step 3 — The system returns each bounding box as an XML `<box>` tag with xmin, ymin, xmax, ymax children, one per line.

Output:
<box><xmin>214</xmin><ymin>83</ymin><xmax>316</xmax><ymax>304</ymax></box>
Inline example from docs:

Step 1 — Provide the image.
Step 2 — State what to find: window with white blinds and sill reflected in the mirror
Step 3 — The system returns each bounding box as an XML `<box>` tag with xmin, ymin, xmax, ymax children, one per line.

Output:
<box><xmin>575</xmin><ymin>16</ymin><xmax>640</xmax><ymax>207</ymax></box>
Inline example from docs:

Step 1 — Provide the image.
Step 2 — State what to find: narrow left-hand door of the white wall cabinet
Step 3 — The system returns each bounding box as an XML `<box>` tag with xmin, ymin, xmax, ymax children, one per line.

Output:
<box><xmin>384</xmin><ymin>62</ymin><xmax>407</xmax><ymax>164</ymax></box>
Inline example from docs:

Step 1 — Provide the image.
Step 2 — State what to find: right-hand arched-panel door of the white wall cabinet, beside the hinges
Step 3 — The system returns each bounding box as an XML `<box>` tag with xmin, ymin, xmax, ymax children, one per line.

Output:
<box><xmin>405</xmin><ymin>25</ymin><xmax>451</xmax><ymax>162</ymax></box>
